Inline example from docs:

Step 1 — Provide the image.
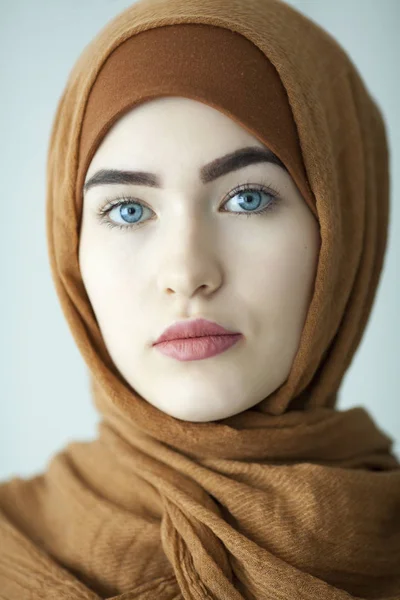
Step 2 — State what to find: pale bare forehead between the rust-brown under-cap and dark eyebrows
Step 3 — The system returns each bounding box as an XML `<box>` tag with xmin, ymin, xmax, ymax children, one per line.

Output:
<box><xmin>87</xmin><ymin>97</ymin><xmax>262</xmax><ymax>170</ymax></box>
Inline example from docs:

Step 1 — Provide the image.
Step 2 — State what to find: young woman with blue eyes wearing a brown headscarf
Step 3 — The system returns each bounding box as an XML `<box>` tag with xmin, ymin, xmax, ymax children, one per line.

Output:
<box><xmin>0</xmin><ymin>0</ymin><xmax>400</xmax><ymax>600</ymax></box>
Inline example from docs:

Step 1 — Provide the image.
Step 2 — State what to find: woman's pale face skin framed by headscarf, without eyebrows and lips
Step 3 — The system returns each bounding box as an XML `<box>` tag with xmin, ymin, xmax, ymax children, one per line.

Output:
<box><xmin>79</xmin><ymin>97</ymin><xmax>320</xmax><ymax>422</ymax></box>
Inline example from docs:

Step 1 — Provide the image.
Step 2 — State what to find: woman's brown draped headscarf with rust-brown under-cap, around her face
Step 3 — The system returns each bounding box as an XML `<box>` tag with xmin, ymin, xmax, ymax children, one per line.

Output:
<box><xmin>0</xmin><ymin>0</ymin><xmax>400</xmax><ymax>600</ymax></box>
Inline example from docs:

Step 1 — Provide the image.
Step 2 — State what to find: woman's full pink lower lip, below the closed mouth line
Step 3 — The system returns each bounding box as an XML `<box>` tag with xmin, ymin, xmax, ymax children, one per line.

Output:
<box><xmin>154</xmin><ymin>333</ymin><xmax>243</xmax><ymax>361</ymax></box>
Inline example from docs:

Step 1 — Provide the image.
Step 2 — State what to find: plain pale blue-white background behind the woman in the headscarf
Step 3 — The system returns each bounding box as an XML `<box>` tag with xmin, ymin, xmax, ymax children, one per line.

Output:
<box><xmin>0</xmin><ymin>0</ymin><xmax>400</xmax><ymax>479</ymax></box>
